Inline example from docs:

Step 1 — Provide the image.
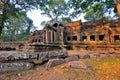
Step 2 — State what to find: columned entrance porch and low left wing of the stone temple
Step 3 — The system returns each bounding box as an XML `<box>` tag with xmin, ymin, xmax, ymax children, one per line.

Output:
<box><xmin>29</xmin><ymin>22</ymin><xmax>65</xmax><ymax>44</ymax></box>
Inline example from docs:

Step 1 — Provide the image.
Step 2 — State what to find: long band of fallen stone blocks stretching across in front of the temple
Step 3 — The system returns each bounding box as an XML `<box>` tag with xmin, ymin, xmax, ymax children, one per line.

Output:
<box><xmin>0</xmin><ymin>50</ymin><xmax>120</xmax><ymax>73</ymax></box>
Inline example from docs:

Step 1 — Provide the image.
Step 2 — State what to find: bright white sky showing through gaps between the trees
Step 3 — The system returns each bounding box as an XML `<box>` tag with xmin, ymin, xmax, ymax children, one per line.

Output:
<box><xmin>27</xmin><ymin>10</ymin><xmax>85</xmax><ymax>30</ymax></box>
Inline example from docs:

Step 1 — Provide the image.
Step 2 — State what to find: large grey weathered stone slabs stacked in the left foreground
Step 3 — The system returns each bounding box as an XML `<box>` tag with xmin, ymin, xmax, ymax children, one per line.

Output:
<box><xmin>0</xmin><ymin>50</ymin><xmax>68</xmax><ymax>73</ymax></box>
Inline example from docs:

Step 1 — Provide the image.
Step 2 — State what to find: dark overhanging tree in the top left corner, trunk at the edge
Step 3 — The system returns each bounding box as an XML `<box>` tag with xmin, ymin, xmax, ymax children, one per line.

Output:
<box><xmin>0</xmin><ymin>0</ymin><xmax>39</xmax><ymax>34</ymax></box>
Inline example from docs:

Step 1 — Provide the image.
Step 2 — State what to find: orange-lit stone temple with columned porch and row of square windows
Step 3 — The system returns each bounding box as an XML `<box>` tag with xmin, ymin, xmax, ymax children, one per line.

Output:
<box><xmin>29</xmin><ymin>19</ymin><xmax>120</xmax><ymax>50</ymax></box>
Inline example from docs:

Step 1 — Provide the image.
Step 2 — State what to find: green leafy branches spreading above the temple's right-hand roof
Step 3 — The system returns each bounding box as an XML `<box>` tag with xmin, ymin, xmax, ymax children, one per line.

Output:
<box><xmin>68</xmin><ymin>0</ymin><xmax>116</xmax><ymax>20</ymax></box>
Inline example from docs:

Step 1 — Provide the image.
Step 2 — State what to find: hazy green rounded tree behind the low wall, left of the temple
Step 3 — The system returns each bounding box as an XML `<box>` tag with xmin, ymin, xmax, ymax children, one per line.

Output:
<box><xmin>2</xmin><ymin>13</ymin><xmax>34</xmax><ymax>41</ymax></box>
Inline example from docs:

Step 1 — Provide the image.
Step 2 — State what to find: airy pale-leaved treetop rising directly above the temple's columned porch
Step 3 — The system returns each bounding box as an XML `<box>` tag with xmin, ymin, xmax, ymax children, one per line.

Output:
<box><xmin>40</xmin><ymin>0</ymin><xmax>70</xmax><ymax>24</ymax></box>
